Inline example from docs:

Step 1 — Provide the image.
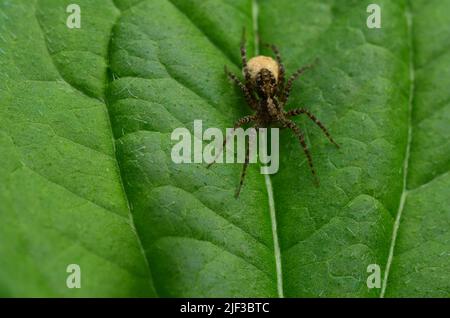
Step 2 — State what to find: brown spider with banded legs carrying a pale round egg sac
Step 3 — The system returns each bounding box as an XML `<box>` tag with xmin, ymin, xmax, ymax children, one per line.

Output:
<box><xmin>208</xmin><ymin>34</ymin><xmax>339</xmax><ymax>198</ymax></box>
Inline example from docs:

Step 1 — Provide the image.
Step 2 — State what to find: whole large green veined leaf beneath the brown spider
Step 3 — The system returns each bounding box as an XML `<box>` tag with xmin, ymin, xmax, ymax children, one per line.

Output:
<box><xmin>0</xmin><ymin>0</ymin><xmax>450</xmax><ymax>297</ymax></box>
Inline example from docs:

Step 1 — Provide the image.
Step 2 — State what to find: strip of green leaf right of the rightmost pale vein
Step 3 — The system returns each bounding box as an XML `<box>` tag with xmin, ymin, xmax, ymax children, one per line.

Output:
<box><xmin>385</xmin><ymin>1</ymin><xmax>450</xmax><ymax>297</ymax></box>
